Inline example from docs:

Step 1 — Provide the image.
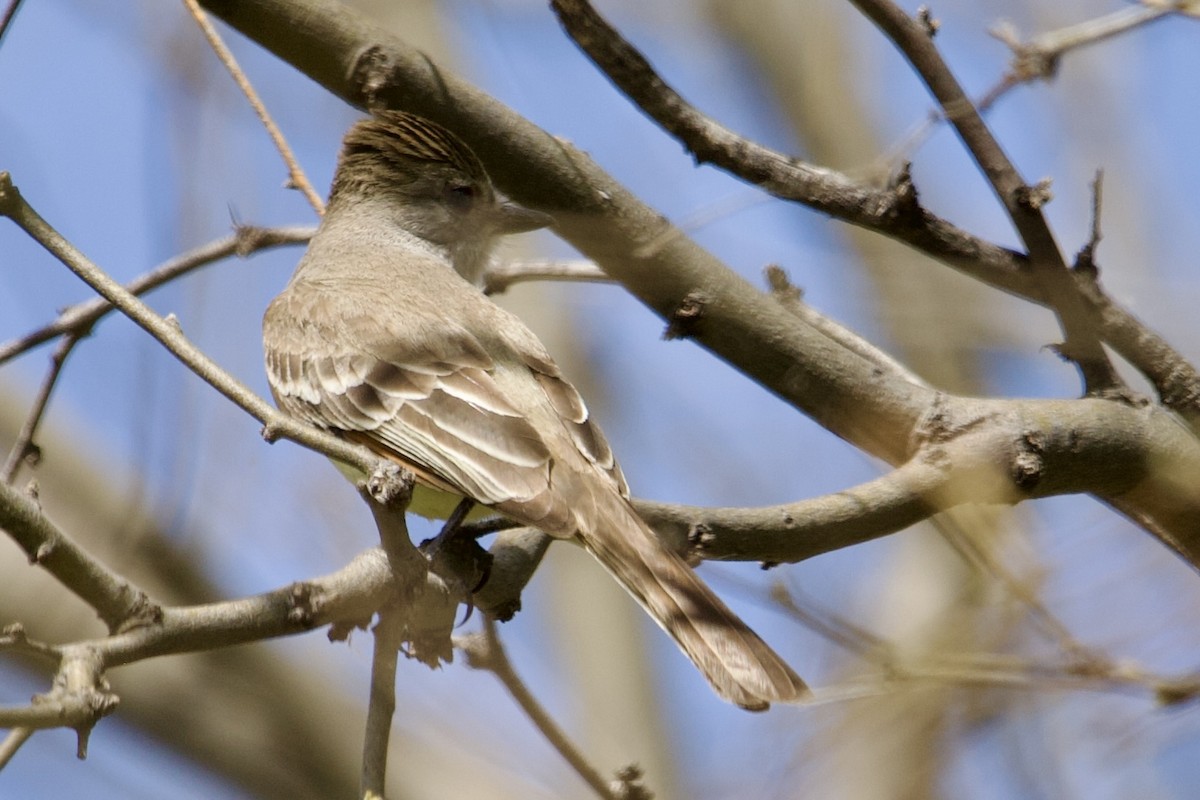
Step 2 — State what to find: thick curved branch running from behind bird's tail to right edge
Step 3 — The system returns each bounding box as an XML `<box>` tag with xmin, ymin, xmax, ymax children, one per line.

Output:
<box><xmin>636</xmin><ymin>396</ymin><xmax>1200</xmax><ymax>569</ymax></box>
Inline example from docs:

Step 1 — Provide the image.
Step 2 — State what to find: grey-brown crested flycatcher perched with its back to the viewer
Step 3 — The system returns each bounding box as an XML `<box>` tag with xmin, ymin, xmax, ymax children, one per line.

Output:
<box><xmin>263</xmin><ymin>112</ymin><xmax>808</xmax><ymax>710</ymax></box>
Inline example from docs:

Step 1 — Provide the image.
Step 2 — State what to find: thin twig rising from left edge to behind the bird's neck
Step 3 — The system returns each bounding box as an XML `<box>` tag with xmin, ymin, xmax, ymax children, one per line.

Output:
<box><xmin>0</xmin><ymin>225</ymin><xmax>316</xmax><ymax>363</ymax></box>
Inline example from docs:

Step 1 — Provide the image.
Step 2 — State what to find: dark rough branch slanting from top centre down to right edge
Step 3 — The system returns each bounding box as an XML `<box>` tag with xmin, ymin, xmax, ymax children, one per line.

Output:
<box><xmin>552</xmin><ymin>0</ymin><xmax>1200</xmax><ymax>422</ymax></box>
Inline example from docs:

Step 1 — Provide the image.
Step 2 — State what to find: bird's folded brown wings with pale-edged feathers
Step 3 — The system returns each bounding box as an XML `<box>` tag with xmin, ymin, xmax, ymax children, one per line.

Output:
<box><xmin>264</xmin><ymin>285</ymin><xmax>600</xmax><ymax>534</ymax></box>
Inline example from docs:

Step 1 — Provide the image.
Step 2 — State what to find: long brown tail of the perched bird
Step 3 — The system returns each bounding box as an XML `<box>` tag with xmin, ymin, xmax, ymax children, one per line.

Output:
<box><xmin>577</xmin><ymin>492</ymin><xmax>809</xmax><ymax>711</ymax></box>
